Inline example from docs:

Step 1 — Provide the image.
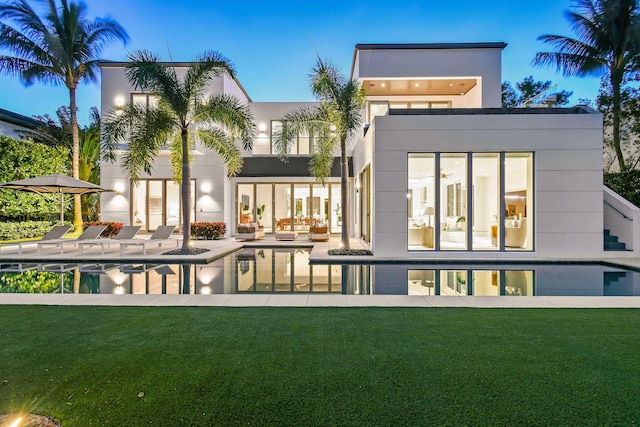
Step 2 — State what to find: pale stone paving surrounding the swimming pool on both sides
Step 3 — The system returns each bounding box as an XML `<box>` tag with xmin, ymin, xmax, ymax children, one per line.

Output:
<box><xmin>0</xmin><ymin>237</ymin><xmax>640</xmax><ymax>308</ymax></box>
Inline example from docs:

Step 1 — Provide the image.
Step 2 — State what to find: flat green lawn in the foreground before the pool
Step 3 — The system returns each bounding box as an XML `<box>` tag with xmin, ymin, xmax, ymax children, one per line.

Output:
<box><xmin>0</xmin><ymin>306</ymin><xmax>640</xmax><ymax>426</ymax></box>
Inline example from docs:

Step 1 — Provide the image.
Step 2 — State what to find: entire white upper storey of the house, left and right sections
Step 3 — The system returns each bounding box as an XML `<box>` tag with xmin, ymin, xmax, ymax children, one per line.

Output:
<box><xmin>100</xmin><ymin>42</ymin><xmax>506</xmax><ymax>157</ymax></box>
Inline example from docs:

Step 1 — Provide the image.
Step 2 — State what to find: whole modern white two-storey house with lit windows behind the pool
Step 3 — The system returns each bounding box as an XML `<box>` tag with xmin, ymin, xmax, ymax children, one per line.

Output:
<box><xmin>101</xmin><ymin>43</ymin><xmax>640</xmax><ymax>260</ymax></box>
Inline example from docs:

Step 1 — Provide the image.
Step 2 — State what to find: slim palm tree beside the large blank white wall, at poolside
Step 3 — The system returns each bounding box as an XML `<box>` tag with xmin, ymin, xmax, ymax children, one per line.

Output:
<box><xmin>274</xmin><ymin>58</ymin><xmax>364</xmax><ymax>249</ymax></box>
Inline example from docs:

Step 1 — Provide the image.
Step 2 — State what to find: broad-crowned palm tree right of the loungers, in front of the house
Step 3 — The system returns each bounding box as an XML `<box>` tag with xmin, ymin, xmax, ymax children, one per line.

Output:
<box><xmin>103</xmin><ymin>51</ymin><xmax>256</xmax><ymax>252</ymax></box>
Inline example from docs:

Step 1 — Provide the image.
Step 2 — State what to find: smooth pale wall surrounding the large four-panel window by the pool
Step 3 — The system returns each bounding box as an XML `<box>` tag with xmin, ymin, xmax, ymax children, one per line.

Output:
<box><xmin>364</xmin><ymin>110</ymin><xmax>603</xmax><ymax>259</ymax></box>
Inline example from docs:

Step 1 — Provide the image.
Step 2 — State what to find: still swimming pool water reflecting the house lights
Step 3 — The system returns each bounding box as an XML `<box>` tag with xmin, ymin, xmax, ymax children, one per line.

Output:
<box><xmin>0</xmin><ymin>248</ymin><xmax>640</xmax><ymax>297</ymax></box>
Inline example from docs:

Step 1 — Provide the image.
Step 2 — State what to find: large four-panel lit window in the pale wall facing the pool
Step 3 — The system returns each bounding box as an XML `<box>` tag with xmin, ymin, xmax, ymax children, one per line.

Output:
<box><xmin>407</xmin><ymin>153</ymin><xmax>534</xmax><ymax>251</ymax></box>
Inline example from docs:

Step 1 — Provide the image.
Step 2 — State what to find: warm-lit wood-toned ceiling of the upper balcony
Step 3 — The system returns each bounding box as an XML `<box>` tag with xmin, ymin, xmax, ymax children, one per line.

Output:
<box><xmin>362</xmin><ymin>79</ymin><xmax>478</xmax><ymax>96</ymax></box>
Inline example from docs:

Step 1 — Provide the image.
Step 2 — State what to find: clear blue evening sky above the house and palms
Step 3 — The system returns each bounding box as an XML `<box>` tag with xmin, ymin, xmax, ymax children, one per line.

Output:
<box><xmin>0</xmin><ymin>0</ymin><xmax>599</xmax><ymax>123</ymax></box>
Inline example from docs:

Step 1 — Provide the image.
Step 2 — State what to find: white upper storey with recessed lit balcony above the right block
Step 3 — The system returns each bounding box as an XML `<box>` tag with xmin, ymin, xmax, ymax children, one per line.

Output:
<box><xmin>351</xmin><ymin>43</ymin><xmax>506</xmax><ymax>128</ymax></box>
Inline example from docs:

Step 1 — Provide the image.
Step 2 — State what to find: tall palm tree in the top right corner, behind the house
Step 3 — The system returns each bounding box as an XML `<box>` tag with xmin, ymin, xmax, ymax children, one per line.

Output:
<box><xmin>534</xmin><ymin>0</ymin><xmax>640</xmax><ymax>170</ymax></box>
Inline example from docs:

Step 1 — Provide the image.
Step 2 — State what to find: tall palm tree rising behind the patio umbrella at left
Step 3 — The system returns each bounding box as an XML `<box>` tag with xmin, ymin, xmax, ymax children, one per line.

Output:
<box><xmin>0</xmin><ymin>0</ymin><xmax>129</xmax><ymax>228</ymax></box>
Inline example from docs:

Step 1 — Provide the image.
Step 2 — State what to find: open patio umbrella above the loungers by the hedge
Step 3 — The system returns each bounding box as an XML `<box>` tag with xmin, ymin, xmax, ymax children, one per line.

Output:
<box><xmin>0</xmin><ymin>174</ymin><xmax>112</xmax><ymax>224</ymax></box>
